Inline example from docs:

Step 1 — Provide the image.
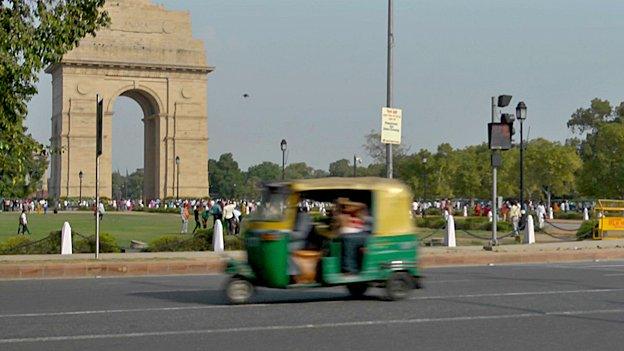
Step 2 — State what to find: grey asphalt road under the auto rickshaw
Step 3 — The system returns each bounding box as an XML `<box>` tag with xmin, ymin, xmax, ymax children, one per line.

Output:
<box><xmin>0</xmin><ymin>261</ymin><xmax>624</xmax><ymax>351</ymax></box>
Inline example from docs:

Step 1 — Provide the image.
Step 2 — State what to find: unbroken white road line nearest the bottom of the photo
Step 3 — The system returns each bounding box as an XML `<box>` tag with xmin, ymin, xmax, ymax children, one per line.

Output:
<box><xmin>0</xmin><ymin>309</ymin><xmax>624</xmax><ymax>344</ymax></box>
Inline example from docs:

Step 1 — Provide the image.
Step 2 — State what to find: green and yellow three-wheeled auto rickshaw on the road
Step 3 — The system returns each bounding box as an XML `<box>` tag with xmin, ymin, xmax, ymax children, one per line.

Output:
<box><xmin>224</xmin><ymin>177</ymin><xmax>420</xmax><ymax>304</ymax></box>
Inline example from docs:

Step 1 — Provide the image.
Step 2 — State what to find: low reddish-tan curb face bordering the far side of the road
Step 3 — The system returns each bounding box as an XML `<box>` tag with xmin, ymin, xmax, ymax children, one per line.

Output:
<box><xmin>0</xmin><ymin>248</ymin><xmax>624</xmax><ymax>280</ymax></box>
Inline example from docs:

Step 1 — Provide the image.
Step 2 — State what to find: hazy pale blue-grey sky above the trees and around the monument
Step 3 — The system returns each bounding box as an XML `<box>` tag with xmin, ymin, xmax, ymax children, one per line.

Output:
<box><xmin>27</xmin><ymin>0</ymin><xmax>624</xmax><ymax>171</ymax></box>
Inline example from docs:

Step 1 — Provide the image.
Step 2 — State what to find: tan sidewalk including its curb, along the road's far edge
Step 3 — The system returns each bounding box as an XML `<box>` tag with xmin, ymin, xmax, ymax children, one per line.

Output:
<box><xmin>0</xmin><ymin>239</ymin><xmax>624</xmax><ymax>279</ymax></box>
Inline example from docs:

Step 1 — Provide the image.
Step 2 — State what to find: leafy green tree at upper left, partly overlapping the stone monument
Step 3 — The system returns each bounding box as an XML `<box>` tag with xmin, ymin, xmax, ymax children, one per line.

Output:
<box><xmin>0</xmin><ymin>0</ymin><xmax>109</xmax><ymax>196</ymax></box>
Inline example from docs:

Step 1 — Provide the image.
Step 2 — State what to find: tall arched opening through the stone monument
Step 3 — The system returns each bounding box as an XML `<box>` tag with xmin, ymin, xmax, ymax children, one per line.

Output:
<box><xmin>111</xmin><ymin>89</ymin><xmax>158</xmax><ymax>200</ymax></box>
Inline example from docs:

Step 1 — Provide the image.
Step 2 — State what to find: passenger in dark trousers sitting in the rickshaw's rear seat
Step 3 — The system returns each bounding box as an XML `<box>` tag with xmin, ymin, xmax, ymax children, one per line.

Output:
<box><xmin>335</xmin><ymin>198</ymin><xmax>370</xmax><ymax>274</ymax></box>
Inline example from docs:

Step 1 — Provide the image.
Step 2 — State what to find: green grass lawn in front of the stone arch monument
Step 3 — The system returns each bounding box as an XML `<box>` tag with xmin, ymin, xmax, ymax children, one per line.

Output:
<box><xmin>0</xmin><ymin>212</ymin><xmax>205</xmax><ymax>247</ymax></box>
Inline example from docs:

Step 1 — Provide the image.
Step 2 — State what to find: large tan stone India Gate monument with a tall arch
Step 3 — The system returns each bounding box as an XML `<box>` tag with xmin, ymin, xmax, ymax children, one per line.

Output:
<box><xmin>46</xmin><ymin>0</ymin><xmax>214</xmax><ymax>199</ymax></box>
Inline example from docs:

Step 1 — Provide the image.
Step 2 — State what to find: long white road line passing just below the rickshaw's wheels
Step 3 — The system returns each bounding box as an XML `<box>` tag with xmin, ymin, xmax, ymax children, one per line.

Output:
<box><xmin>0</xmin><ymin>288</ymin><xmax>624</xmax><ymax>319</ymax></box>
